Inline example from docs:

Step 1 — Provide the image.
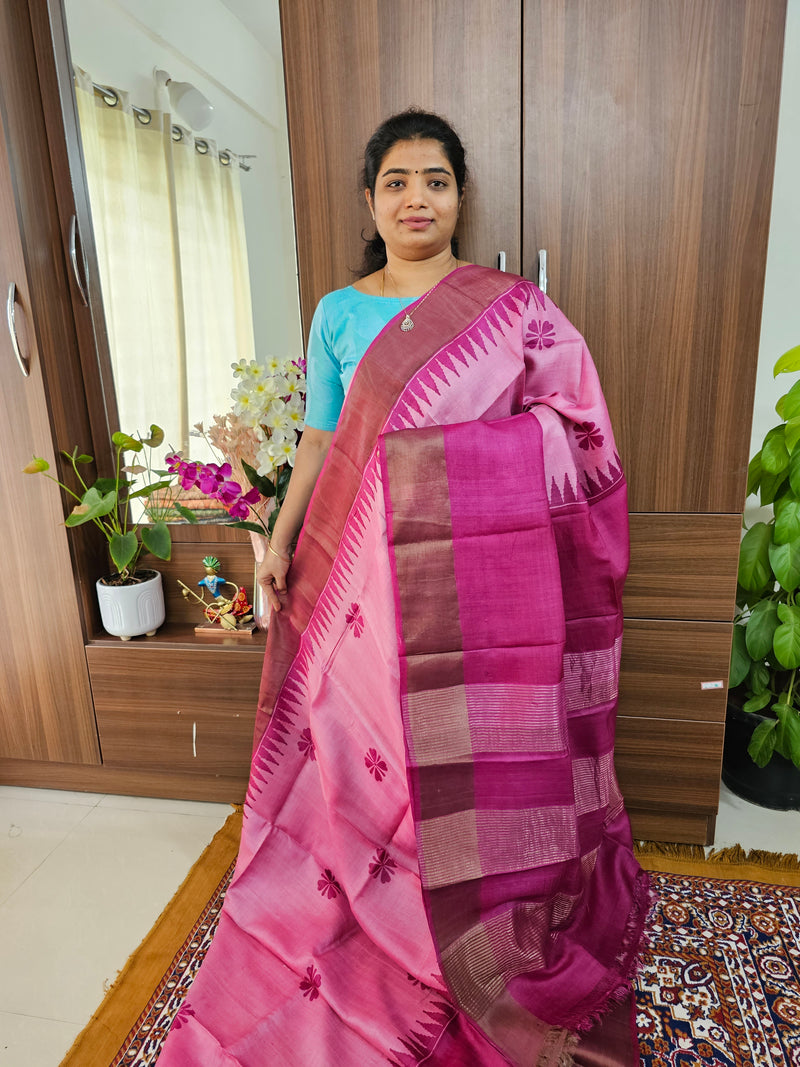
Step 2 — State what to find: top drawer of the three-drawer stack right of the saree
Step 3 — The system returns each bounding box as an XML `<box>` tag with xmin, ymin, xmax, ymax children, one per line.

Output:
<box><xmin>623</xmin><ymin>512</ymin><xmax>741</xmax><ymax>622</ymax></box>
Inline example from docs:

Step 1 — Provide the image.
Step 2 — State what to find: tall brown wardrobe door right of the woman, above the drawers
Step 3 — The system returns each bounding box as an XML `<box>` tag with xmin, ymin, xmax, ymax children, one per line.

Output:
<box><xmin>523</xmin><ymin>0</ymin><xmax>785</xmax><ymax>513</ymax></box>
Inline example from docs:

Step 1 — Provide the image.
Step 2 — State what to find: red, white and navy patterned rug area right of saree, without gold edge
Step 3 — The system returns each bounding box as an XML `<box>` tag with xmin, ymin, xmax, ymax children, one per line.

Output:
<box><xmin>636</xmin><ymin>874</ymin><xmax>800</xmax><ymax>1067</ymax></box>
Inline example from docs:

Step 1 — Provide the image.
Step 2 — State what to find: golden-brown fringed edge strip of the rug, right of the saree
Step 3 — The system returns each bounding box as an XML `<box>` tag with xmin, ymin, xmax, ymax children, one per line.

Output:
<box><xmin>635</xmin><ymin>841</ymin><xmax>800</xmax><ymax>886</ymax></box>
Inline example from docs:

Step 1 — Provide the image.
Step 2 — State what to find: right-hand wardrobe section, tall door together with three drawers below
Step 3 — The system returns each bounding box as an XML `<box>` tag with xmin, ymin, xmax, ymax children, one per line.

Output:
<box><xmin>523</xmin><ymin>0</ymin><xmax>785</xmax><ymax>843</ymax></box>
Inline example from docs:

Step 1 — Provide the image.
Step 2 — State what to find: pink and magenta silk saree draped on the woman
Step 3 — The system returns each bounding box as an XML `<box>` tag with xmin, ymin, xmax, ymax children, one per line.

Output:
<box><xmin>159</xmin><ymin>267</ymin><xmax>650</xmax><ymax>1067</ymax></box>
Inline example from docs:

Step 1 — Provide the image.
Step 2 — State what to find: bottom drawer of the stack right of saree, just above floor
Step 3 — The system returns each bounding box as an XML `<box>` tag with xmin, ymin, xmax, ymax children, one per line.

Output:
<box><xmin>614</xmin><ymin>716</ymin><xmax>725</xmax><ymax>814</ymax></box>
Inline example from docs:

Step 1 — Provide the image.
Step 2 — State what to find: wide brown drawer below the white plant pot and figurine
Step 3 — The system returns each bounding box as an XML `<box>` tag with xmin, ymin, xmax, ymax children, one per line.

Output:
<box><xmin>86</xmin><ymin>647</ymin><xmax>261</xmax><ymax>778</ymax></box>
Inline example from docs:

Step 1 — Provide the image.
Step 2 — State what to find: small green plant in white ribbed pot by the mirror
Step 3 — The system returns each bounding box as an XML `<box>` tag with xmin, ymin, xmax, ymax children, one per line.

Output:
<box><xmin>23</xmin><ymin>426</ymin><xmax>187</xmax><ymax>640</ymax></box>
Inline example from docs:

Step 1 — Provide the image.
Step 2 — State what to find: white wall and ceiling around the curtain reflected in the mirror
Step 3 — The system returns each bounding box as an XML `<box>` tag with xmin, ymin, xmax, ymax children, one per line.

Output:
<box><xmin>65</xmin><ymin>0</ymin><xmax>302</xmax><ymax>364</ymax></box>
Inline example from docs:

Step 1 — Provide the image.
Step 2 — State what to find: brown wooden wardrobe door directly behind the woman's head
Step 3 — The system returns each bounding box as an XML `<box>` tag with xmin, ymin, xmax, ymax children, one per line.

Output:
<box><xmin>281</xmin><ymin>0</ymin><xmax>522</xmax><ymax>332</ymax></box>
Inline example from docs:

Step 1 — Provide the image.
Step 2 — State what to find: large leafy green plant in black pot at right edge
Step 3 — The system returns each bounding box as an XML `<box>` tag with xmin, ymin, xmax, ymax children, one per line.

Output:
<box><xmin>722</xmin><ymin>345</ymin><xmax>800</xmax><ymax>809</ymax></box>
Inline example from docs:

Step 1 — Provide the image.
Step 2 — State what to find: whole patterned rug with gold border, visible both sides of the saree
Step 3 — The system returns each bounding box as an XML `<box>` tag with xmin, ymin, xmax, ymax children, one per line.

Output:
<box><xmin>62</xmin><ymin>816</ymin><xmax>800</xmax><ymax>1067</ymax></box>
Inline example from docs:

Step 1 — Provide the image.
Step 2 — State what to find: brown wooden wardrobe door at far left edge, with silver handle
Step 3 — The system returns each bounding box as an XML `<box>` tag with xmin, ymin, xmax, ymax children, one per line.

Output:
<box><xmin>0</xmin><ymin>2</ymin><xmax>99</xmax><ymax>763</ymax></box>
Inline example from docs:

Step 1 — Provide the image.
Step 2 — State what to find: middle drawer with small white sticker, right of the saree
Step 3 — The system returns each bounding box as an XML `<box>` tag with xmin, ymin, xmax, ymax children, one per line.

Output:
<box><xmin>618</xmin><ymin>619</ymin><xmax>733</xmax><ymax>723</ymax></box>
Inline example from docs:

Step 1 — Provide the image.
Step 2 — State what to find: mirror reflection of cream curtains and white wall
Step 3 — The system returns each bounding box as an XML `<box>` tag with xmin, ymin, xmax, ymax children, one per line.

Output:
<box><xmin>64</xmin><ymin>0</ymin><xmax>302</xmax><ymax>521</ymax></box>
